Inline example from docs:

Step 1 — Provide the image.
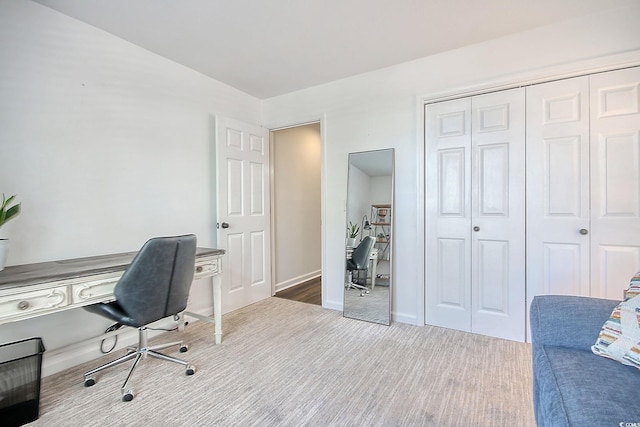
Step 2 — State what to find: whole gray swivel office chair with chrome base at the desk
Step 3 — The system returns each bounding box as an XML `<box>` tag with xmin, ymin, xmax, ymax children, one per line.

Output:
<box><xmin>84</xmin><ymin>234</ymin><xmax>196</xmax><ymax>402</ymax></box>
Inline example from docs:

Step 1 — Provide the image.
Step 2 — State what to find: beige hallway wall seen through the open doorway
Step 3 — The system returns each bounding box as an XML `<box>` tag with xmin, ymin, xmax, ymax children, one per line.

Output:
<box><xmin>271</xmin><ymin>123</ymin><xmax>322</xmax><ymax>291</ymax></box>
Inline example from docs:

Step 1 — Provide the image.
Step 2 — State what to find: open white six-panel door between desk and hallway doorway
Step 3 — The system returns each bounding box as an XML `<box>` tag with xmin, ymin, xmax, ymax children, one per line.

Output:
<box><xmin>216</xmin><ymin>117</ymin><xmax>271</xmax><ymax>313</ymax></box>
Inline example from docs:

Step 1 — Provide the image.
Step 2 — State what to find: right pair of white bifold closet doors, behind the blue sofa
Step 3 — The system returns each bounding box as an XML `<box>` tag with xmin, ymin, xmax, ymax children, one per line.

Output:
<box><xmin>527</xmin><ymin>68</ymin><xmax>640</xmax><ymax>306</ymax></box>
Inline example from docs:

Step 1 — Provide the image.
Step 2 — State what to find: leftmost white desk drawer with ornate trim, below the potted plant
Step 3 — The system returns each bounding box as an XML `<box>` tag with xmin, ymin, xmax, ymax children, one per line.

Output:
<box><xmin>0</xmin><ymin>286</ymin><xmax>69</xmax><ymax>320</ymax></box>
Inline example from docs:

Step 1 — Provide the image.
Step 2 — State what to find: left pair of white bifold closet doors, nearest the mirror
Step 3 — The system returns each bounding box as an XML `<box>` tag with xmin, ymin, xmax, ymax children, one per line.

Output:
<box><xmin>425</xmin><ymin>89</ymin><xmax>525</xmax><ymax>341</ymax></box>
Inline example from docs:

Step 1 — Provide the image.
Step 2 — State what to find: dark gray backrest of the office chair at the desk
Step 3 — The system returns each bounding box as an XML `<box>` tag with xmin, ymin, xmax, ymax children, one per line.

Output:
<box><xmin>114</xmin><ymin>234</ymin><xmax>196</xmax><ymax>326</ymax></box>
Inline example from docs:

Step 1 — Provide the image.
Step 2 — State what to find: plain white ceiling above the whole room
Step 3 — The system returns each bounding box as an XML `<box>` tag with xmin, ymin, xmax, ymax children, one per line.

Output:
<box><xmin>34</xmin><ymin>0</ymin><xmax>637</xmax><ymax>99</ymax></box>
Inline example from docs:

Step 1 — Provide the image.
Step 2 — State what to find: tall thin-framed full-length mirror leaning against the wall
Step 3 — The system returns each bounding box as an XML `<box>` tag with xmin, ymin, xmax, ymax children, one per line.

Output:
<box><xmin>343</xmin><ymin>149</ymin><xmax>394</xmax><ymax>325</ymax></box>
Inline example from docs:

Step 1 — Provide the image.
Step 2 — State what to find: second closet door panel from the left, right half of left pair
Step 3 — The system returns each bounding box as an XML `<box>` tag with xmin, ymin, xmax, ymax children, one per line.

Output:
<box><xmin>471</xmin><ymin>89</ymin><xmax>526</xmax><ymax>341</ymax></box>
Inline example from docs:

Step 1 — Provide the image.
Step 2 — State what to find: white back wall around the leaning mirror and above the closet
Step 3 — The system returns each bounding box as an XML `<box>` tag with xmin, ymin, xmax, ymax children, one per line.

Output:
<box><xmin>263</xmin><ymin>4</ymin><xmax>640</xmax><ymax>324</ymax></box>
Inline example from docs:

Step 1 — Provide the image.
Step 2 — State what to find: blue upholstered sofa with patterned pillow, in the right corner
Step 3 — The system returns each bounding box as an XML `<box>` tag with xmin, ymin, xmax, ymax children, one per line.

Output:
<box><xmin>530</xmin><ymin>295</ymin><xmax>640</xmax><ymax>427</ymax></box>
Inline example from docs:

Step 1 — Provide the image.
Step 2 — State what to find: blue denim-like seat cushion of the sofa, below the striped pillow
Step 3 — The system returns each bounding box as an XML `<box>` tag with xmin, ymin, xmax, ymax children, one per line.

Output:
<box><xmin>534</xmin><ymin>346</ymin><xmax>640</xmax><ymax>426</ymax></box>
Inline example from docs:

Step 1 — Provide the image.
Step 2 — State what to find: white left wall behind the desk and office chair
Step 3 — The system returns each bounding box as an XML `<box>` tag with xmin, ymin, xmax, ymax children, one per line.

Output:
<box><xmin>0</xmin><ymin>0</ymin><xmax>261</xmax><ymax>373</ymax></box>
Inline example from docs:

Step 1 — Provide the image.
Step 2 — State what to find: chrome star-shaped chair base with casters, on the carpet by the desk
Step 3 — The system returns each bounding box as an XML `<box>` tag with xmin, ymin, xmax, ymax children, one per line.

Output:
<box><xmin>84</xmin><ymin>327</ymin><xmax>196</xmax><ymax>402</ymax></box>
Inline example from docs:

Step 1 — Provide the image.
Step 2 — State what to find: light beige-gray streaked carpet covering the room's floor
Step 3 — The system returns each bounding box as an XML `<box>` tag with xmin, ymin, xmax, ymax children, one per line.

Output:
<box><xmin>31</xmin><ymin>298</ymin><xmax>535</xmax><ymax>426</ymax></box>
